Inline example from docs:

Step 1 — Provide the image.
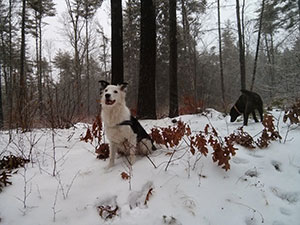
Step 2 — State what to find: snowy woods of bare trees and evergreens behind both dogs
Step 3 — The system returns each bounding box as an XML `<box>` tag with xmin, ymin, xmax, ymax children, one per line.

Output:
<box><xmin>0</xmin><ymin>0</ymin><xmax>300</xmax><ymax>131</ymax></box>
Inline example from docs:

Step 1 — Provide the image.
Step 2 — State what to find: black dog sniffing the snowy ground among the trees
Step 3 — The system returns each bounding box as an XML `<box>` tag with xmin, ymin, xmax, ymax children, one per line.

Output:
<box><xmin>230</xmin><ymin>90</ymin><xmax>263</xmax><ymax>126</ymax></box>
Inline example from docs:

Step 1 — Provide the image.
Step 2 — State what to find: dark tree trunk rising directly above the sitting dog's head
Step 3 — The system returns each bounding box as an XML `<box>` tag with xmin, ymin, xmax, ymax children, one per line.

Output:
<box><xmin>111</xmin><ymin>0</ymin><xmax>124</xmax><ymax>84</ymax></box>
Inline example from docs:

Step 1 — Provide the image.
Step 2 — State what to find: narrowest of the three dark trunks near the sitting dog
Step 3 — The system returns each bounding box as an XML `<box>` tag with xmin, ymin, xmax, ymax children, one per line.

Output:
<box><xmin>169</xmin><ymin>0</ymin><xmax>178</xmax><ymax>118</ymax></box>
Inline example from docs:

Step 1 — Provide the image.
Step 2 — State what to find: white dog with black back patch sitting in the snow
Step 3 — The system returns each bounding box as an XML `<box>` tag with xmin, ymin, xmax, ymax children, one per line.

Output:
<box><xmin>99</xmin><ymin>80</ymin><xmax>156</xmax><ymax>168</ymax></box>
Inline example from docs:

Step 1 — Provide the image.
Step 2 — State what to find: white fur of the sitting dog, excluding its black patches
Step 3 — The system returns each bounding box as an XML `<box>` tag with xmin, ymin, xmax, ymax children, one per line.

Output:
<box><xmin>101</xmin><ymin>85</ymin><xmax>151</xmax><ymax>168</ymax></box>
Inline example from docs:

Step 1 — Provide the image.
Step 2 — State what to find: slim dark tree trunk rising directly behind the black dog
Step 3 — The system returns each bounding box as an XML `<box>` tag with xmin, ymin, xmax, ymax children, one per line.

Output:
<box><xmin>236</xmin><ymin>0</ymin><xmax>246</xmax><ymax>89</ymax></box>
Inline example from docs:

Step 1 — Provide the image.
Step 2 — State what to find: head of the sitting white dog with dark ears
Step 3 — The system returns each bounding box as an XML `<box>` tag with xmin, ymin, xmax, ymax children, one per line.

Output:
<box><xmin>99</xmin><ymin>80</ymin><xmax>128</xmax><ymax>107</ymax></box>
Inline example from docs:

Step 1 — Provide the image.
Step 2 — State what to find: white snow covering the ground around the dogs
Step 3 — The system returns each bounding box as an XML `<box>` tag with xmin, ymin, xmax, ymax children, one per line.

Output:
<box><xmin>0</xmin><ymin>109</ymin><xmax>300</xmax><ymax>225</ymax></box>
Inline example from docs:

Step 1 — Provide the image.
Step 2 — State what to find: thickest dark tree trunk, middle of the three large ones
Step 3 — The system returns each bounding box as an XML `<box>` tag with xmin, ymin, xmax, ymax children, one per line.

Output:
<box><xmin>137</xmin><ymin>0</ymin><xmax>156</xmax><ymax>119</ymax></box>
